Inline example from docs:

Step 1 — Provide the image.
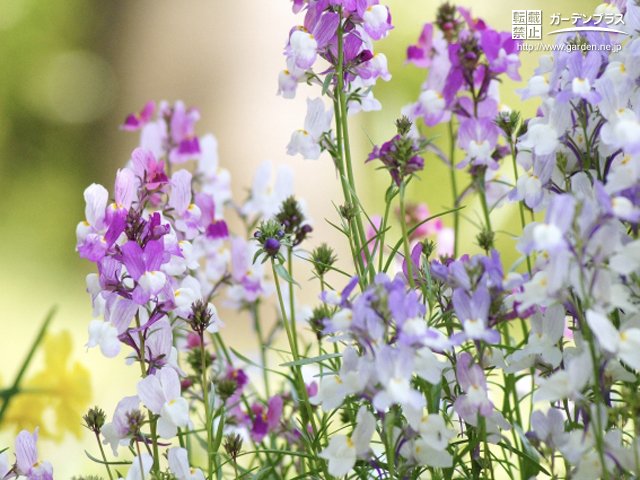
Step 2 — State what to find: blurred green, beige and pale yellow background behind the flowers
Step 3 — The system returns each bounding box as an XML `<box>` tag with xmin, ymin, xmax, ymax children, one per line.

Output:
<box><xmin>0</xmin><ymin>0</ymin><xmax>598</xmax><ymax>478</ymax></box>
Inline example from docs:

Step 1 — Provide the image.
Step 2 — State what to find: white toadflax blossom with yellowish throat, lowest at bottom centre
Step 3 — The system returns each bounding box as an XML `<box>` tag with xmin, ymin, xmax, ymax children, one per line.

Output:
<box><xmin>320</xmin><ymin>406</ymin><xmax>376</xmax><ymax>477</ymax></box>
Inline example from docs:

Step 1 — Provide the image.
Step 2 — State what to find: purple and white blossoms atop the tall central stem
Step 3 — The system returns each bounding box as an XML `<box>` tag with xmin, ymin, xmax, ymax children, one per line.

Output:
<box><xmin>278</xmin><ymin>0</ymin><xmax>393</xmax><ymax>160</ymax></box>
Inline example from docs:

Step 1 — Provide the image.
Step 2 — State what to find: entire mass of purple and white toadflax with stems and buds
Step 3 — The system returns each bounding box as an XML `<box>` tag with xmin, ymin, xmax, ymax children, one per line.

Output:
<box><xmin>17</xmin><ymin>0</ymin><xmax>640</xmax><ymax>480</ymax></box>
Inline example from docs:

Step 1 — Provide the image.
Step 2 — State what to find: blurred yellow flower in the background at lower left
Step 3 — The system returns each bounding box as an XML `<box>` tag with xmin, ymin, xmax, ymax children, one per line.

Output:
<box><xmin>5</xmin><ymin>331</ymin><xmax>91</xmax><ymax>440</ymax></box>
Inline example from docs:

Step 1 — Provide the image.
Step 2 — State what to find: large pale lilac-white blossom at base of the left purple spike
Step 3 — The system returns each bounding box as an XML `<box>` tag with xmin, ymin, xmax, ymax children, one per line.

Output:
<box><xmin>138</xmin><ymin>367</ymin><xmax>189</xmax><ymax>438</ymax></box>
